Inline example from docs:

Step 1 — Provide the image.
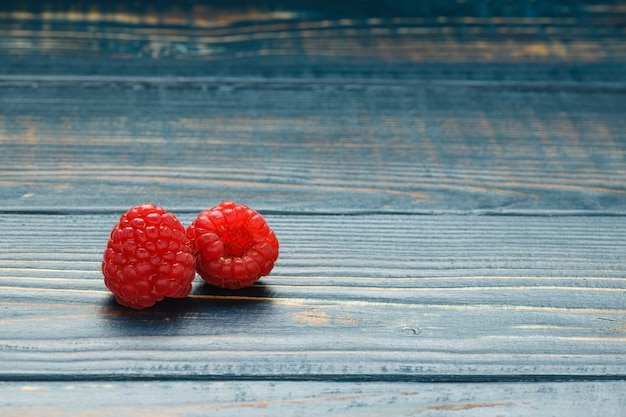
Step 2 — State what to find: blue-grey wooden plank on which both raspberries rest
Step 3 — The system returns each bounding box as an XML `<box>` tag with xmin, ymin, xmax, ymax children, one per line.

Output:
<box><xmin>0</xmin><ymin>213</ymin><xmax>626</xmax><ymax>381</ymax></box>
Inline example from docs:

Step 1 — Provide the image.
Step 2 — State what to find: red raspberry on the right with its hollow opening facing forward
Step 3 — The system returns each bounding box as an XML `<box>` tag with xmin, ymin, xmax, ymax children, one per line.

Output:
<box><xmin>187</xmin><ymin>201</ymin><xmax>278</xmax><ymax>289</ymax></box>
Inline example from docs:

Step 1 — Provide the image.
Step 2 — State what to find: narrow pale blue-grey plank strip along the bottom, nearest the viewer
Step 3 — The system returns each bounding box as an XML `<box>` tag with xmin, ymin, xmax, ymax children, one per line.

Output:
<box><xmin>0</xmin><ymin>381</ymin><xmax>626</xmax><ymax>417</ymax></box>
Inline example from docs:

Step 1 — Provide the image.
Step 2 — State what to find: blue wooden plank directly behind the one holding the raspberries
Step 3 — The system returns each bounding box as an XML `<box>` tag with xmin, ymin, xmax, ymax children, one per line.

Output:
<box><xmin>0</xmin><ymin>77</ymin><xmax>626</xmax><ymax>214</ymax></box>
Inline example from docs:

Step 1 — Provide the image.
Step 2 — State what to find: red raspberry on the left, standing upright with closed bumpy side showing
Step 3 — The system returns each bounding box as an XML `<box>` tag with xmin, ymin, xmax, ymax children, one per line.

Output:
<box><xmin>102</xmin><ymin>203</ymin><xmax>195</xmax><ymax>309</ymax></box>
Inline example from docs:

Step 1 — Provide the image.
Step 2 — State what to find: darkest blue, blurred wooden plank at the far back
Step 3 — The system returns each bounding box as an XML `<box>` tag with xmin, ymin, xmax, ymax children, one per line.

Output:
<box><xmin>0</xmin><ymin>0</ymin><xmax>626</xmax><ymax>82</ymax></box>
